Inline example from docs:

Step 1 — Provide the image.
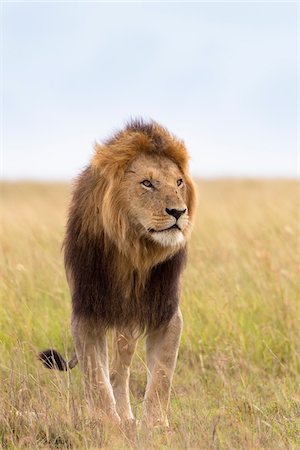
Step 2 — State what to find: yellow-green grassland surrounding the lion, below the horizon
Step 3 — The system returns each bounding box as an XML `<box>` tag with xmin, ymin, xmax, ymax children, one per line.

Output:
<box><xmin>0</xmin><ymin>180</ymin><xmax>300</xmax><ymax>449</ymax></box>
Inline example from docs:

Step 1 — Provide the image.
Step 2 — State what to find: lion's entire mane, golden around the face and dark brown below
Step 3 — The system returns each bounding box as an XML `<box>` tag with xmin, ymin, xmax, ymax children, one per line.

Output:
<box><xmin>64</xmin><ymin>120</ymin><xmax>195</xmax><ymax>329</ymax></box>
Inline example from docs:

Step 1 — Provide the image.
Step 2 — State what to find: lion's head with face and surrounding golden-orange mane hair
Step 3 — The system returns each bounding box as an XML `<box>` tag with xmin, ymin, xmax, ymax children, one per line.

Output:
<box><xmin>92</xmin><ymin>121</ymin><xmax>195</xmax><ymax>255</ymax></box>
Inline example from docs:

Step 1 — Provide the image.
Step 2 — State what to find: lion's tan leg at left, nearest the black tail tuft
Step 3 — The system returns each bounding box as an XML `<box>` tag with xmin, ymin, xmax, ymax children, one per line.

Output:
<box><xmin>72</xmin><ymin>317</ymin><xmax>120</xmax><ymax>423</ymax></box>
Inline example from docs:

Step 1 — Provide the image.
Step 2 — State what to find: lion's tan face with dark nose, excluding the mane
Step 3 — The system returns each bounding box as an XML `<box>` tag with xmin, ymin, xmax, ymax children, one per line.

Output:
<box><xmin>122</xmin><ymin>155</ymin><xmax>189</xmax><ymax>247</ymax></box>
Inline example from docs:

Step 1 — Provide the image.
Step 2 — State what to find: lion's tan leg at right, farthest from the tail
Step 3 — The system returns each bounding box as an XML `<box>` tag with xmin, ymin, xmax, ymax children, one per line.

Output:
<box><xmin>143</xmin><ymin>309</ymin><xmax>182</xmax><ymax>426</ymax></box>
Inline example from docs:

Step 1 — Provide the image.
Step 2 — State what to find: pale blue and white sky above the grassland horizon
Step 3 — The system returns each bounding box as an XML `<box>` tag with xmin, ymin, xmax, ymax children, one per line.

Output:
<box><xmin>1</xmin><ymin>1</ymin><xmax>299</xmax><ymax>180</ymax></box>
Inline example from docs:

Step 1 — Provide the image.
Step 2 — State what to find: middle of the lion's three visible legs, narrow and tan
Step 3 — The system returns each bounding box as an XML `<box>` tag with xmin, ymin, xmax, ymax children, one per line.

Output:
<box><xmin>110</xmin><ymin>330</ymin><xmax>137</xmax><ymax>421</ymax></box>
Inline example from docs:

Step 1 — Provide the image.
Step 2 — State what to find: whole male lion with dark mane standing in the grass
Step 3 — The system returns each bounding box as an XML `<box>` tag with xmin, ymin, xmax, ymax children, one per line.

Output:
<box><xmin>39</xmin><ymin>120</ymin><xmax>195</xmax><ymax>426</ymax></box>
